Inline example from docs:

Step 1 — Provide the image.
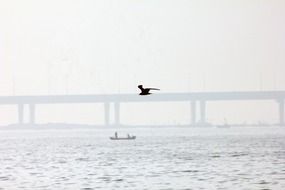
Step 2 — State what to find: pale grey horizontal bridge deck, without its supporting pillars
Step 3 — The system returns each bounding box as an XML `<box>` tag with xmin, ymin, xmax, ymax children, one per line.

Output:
<box><xmin>0</xmin><ymin>91</ymin><xmax>285</xmax><ymax>104</ymax></box>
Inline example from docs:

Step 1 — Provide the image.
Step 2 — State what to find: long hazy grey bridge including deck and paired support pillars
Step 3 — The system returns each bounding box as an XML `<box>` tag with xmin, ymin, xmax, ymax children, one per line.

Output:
<box><xmin>0</xmin><ymin>91</ymin><xmax>285</xmax><ymax>126</ymax></box>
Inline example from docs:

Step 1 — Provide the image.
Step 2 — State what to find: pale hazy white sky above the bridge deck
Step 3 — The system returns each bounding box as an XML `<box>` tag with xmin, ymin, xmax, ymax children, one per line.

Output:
<box><xmin>0</xmin><ymin>0</ymin><xmax>285</xmax><ymax>124</ymax></box>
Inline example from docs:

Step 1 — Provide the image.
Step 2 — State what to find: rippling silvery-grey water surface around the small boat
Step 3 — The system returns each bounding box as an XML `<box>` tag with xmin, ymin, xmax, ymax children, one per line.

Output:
<box><xmin>0</xmin><ymin>127</ymin><xmax>285</xmax><ymax>190</ymax></box>
